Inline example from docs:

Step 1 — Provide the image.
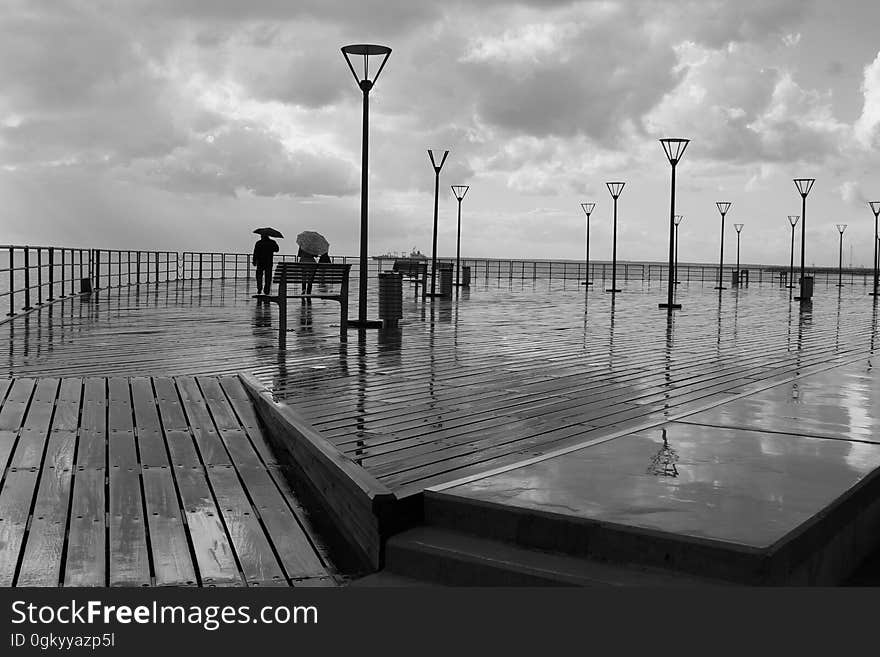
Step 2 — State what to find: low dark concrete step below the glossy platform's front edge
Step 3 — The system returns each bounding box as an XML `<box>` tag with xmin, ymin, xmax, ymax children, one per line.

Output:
<box><xmin>384</xmin><ymin>526</ymin><xmax>722</xmax><ymax>587</ymax></box>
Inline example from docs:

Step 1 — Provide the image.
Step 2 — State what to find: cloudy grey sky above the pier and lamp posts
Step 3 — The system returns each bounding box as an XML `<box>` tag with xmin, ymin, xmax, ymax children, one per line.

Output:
<box><xmin>0</xmin><ymin>0</ymin><xmax>880</xmax><ymax>265</ymax></box>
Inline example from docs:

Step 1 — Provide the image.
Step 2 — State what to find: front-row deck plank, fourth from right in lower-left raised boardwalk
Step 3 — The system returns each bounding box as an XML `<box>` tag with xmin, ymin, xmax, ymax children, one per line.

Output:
<box><xmin>143</xmin><ymin>467</ymin><xmax>196</xmax><ymax>586</ymax></box>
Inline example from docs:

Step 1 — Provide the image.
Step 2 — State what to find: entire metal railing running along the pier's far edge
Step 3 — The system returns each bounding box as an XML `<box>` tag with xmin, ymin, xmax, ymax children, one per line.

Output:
<box><xmin>0</xmin><ymin>245</ymin><xmax>872</xmax><ymax>317</ymax></box>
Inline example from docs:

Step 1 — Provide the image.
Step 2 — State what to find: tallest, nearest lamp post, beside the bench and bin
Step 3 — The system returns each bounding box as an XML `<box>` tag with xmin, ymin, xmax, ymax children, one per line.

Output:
<box><xmin>342</xmin><ymin>44</ymin><xmax>391</xmax><ymax>329</ymax></box>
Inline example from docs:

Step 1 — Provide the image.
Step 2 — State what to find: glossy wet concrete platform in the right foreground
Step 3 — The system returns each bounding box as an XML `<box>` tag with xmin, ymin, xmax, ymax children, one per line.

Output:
<box><xmin>434</xmin><ymin>361</ymin><xmax>880</xmax><ymax>584</ymax></box>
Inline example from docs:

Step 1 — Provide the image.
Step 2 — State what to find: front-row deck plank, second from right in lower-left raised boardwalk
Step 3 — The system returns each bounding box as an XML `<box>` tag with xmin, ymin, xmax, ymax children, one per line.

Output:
<box><xmin>208</xmin><ymin>466</ymin><xmax>285</xmax><ymax>586</ymax></box>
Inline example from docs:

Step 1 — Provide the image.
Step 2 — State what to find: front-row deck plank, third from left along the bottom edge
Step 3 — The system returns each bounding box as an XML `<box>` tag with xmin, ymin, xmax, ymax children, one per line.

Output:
<box><xmin>64</xmin><ymin>468</ymin><xmax>107</xmax><ymax>586</ymax></box>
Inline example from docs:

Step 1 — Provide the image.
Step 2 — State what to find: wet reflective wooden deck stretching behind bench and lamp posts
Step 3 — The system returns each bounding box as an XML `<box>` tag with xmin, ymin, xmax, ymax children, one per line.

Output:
<box><xmin>0</xmin><ymin>280</ymin><xmax>877</xmax><ymax>496</ymax></box>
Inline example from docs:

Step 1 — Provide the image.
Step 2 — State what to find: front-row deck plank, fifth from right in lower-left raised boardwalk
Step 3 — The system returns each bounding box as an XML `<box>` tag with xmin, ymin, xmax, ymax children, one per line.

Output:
<box><xmin>109</xmin><ymin>466</ymin><xmax>151</xmax><ymax>586</ymax></box>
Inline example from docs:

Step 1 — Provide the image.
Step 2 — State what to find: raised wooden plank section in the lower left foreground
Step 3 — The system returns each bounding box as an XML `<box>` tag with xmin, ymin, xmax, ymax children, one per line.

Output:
<box><xmin>0</xmin><ymin>376</ymin><xmax>335</xmax><ymax>586</ymax></box>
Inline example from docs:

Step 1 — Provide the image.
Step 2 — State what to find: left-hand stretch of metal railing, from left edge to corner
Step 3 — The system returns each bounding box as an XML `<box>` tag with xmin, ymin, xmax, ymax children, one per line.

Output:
<box><xmin>0</xmin><ymin>245</ymin><xmax>178</xmax><ymax>317</ymax></box>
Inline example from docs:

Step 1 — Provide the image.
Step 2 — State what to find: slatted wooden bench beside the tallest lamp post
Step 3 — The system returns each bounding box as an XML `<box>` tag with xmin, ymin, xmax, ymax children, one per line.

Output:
<box><xmin>265</xmin><ymin>262</ymin><xmax>351</xmax><ymax>349</ymax></box>
